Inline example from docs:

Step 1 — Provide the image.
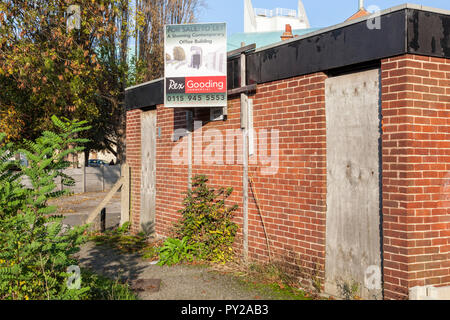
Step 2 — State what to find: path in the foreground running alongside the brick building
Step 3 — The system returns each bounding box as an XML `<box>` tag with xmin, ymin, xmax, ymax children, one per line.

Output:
<box><xmin>76</xmin><ymin>243</ymin><xmax>273</xmax><ymax>300</ymax></box>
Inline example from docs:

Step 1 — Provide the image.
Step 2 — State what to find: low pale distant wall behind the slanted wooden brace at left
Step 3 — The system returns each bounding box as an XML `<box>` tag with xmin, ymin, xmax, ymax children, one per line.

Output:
<box><xmin>22</xmin><ymin>165</ymin><xmax>120</xmax><ymax>193</ymax></box>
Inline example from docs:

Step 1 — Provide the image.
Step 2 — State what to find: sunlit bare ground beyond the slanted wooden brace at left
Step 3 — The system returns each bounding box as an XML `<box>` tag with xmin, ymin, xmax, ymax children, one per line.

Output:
<box><xmin>51</xmin><ymin>192</ymin><xmax>120</xmax><ymax>228</ymax></box>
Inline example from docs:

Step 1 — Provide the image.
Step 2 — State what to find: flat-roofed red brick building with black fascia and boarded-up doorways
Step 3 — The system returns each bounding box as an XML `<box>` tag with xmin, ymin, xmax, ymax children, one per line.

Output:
<box><xmin>126</xmin><ymin>5</ymin><xmax>450</xmax><ymax>299</ymax></box>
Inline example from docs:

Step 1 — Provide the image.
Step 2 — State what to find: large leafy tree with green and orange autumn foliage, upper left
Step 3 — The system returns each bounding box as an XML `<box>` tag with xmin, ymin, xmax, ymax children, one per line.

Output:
<box><xmin>0</xmin><ymin>0</ymin><xmax>128</xmax><ymax>164</ymax></box>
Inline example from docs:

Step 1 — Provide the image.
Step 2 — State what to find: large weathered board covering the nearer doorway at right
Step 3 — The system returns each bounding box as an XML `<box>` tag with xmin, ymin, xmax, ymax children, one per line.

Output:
<box><xmin>325</xmin><ymin>69</ymin><xmax>382</xmax><ymax>299</ymax></box>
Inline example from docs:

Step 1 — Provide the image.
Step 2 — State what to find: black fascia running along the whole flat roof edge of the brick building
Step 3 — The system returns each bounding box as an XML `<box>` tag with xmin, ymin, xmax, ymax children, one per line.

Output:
<box><xmin>125</xmin><ymin>4</ymin><xmax>450</xmax><ymax>110</ymax></box>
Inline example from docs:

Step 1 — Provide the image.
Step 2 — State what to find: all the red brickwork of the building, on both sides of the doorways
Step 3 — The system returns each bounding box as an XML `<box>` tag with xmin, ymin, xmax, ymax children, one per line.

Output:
<box><xmin>127</xmin><ymin>55</ymin><xmax>450</xmax><ymax>299</ymax></box>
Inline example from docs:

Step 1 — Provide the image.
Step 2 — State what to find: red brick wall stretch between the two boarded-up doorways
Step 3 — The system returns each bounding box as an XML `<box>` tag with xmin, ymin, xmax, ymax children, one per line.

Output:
<box><xmin>147</xmin><ymin>73</ymin><xmax>326</xmax><ymax>290</ymax></box>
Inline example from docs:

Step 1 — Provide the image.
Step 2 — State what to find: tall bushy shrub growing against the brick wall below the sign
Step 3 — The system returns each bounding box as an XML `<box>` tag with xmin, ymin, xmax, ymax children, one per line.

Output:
<box><xmin>175</xmin><ymin>175</ymin><xmax>238</xmax><ymax>262</ymax></box>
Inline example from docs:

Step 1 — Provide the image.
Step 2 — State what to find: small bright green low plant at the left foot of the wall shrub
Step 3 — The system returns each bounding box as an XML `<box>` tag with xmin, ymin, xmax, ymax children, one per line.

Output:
<box><xmin>158</xmin><ymin>237</ymin><xmax>197</xmax><ymax>266</ymax></box>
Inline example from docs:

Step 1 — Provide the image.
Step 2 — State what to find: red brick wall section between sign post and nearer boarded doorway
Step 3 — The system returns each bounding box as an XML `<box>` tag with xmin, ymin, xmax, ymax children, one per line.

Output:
<box><xmin>249</xmin><ymin>73</ymin><xmax>327</xmax><ymax>285</ymax></box>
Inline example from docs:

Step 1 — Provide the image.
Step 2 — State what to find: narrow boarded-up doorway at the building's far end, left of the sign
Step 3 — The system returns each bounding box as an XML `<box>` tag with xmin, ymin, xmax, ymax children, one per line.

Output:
<box><xmin>140</xmin><ymin>110</ymin><xmax>156</xmax><ymax>234</ymax></box>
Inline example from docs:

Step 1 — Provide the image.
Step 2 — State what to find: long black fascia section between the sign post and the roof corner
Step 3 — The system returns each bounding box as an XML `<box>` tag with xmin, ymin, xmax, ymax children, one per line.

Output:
<box><xmin>247</xmin><ymin>11</ymin><xmax>406</xmax><ymax>83</ymax></box>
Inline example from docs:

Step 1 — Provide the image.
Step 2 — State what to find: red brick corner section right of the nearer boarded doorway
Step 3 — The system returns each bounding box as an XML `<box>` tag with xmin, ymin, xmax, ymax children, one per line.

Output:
<box><xmin>382</xmin><ymin>55</ymin><xmax>450</xmax><ymax>299</ymax></box>
